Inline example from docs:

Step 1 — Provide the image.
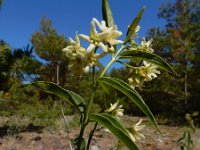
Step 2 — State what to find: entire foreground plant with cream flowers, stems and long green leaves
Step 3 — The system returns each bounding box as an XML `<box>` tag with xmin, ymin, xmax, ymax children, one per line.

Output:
<box><xmin>32</xmin><ymin>0</ymin><xmax>176</xmax><ymax>150</ymax></box>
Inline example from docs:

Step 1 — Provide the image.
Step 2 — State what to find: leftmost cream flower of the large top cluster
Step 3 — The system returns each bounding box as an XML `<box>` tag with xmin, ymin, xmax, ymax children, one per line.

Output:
<box><xmin>63</xmin><ymin>35</ymin><xmax>86</xmax><ymax>60</ymax></box>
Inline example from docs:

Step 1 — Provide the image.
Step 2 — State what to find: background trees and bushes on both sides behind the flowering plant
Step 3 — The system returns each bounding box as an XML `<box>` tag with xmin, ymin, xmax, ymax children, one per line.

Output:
<box><xmin>0</xmin><ymin>0</ymin><xmax>200</xmax><ymax>130</ymax></box>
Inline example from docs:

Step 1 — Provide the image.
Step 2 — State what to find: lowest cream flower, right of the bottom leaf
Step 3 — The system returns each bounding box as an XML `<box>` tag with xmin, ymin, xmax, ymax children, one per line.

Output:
<box><xmin>128</xmin><ymin>119</ymin><xmax>145</xmax><ymax>142</ymax></box>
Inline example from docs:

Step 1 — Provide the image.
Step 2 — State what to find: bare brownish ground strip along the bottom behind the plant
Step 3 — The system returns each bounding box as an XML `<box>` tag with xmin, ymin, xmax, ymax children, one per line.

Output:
<box><xmin>0</xmin><ymin>117</ymin><xmax>200</xmax><ymax>150</ymax></box>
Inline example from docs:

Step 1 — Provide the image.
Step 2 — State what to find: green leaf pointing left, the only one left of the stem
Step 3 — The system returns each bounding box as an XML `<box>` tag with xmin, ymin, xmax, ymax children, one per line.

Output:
<box><xmin>31</xmin><ymin>81</ymin><xmax>86</xmax><ymax>113</ymax></box>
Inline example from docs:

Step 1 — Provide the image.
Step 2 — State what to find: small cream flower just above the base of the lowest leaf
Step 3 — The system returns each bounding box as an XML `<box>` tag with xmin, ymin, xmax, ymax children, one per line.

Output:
<box><xmin>105</xmin><ymin>101</ymin><xmax>124</xmax><ymax>119</ymax></box>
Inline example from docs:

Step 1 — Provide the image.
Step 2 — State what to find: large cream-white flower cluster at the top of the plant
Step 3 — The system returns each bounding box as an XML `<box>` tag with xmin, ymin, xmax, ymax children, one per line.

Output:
<box><xmin>63</xmin><ymin>18</ymin><xmax>123</xmax><ymax>72</ymax></box>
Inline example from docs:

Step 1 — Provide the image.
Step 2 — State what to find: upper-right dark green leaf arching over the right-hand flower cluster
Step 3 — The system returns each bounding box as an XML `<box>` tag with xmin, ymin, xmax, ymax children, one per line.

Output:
<box><xmin>119</xmin><ymin>49</ymin><xmax>177</xmax><ymax>75</ymax></box>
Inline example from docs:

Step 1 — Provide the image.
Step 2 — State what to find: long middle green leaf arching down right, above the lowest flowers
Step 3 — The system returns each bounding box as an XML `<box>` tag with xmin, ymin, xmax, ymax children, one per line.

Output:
<box><xmin>97</xmin><ymin>77</ymin><xmax>160</xmax><ymax>132</ymax></box>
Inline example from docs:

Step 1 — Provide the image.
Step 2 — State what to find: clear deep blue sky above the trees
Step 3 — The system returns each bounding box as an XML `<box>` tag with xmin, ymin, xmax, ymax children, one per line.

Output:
<box><xmin>0</xmin><ymin>0</ymin><xmax>173</xmax><ymax>48</ymax></box>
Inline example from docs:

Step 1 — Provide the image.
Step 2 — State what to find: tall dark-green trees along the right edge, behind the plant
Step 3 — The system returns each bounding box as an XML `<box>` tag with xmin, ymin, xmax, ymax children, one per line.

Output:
<box><xmin>143</xmin><ymin>0</ymin><xmax>200</xmax><ymax>123</ymax></box>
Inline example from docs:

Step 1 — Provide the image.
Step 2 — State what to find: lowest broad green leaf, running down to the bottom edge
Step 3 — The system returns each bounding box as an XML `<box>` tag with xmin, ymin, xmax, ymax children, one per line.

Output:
<box><xmin>89</xmin><ymin>113</ymin><xmax>139</xmax><ymax>150</ymax></box>
